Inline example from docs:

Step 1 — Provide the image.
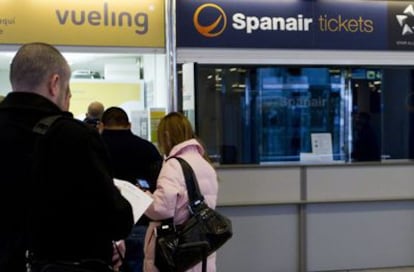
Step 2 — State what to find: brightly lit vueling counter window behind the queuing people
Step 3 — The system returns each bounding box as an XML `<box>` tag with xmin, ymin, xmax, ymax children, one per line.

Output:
<box><xmin>0</xmin><ymin>48</ymin><xmax>168</xmax><ymax>142</ymax></box>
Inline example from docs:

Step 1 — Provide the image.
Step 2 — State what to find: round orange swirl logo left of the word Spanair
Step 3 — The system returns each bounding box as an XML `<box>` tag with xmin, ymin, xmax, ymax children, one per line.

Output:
<box><xmin>193</xmin><ymin>3</ymin><xmax>227</xmax><ymax>38</ymax></box>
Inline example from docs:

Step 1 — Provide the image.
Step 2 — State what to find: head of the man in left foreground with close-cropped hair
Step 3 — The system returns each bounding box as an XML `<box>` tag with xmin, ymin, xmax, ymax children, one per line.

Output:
<box><xmin>10</xmin><ymin>43</ymin><xmax>71</xmax><ymax>111</ymax></box>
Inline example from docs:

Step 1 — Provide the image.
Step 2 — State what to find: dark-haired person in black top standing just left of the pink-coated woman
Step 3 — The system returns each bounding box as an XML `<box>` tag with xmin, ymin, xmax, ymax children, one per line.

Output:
<box><xmin>102</xmin><ymin>107</ymin><xmax>162</xmax><ymax>272</ymax></box>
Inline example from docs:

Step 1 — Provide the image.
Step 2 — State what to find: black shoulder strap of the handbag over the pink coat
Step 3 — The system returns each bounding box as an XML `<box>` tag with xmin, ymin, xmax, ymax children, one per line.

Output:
<box><xmin>171</xmin><ymin>156</ymin><xmax>204</xmax><ymax>209</ymax></box>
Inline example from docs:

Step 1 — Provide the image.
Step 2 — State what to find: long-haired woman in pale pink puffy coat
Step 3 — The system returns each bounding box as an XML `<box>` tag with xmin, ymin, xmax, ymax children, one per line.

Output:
<box><xmin>144</xmin><ymin>112</ymin><xmax>218</xmax><ymax>272</ymax></box>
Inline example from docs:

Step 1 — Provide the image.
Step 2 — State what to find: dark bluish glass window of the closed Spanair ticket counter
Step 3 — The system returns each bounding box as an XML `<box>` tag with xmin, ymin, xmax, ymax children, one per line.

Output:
<box><xmin>191</xmin><ymin>64</ymin><xmax>414</xmax><ymax>164</ymax></box>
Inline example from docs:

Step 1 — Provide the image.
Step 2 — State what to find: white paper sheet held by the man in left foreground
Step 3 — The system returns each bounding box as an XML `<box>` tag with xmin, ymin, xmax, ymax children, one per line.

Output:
<box><xmin>114</xmin><ymin>179</ymin><xmax>152</xmax><ymax>222</ymax></box>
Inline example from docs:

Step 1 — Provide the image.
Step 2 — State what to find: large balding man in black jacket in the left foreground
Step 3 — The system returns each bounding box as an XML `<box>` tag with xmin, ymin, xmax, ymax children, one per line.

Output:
<box><xmin>0</xmin><ymin>43</ymin><xmax>133</xmax><ymax>272</ymax></box>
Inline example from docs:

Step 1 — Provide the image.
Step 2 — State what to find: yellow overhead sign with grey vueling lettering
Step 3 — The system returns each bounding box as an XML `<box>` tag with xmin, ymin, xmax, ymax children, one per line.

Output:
<box><xmin>0</xmin><ymin>0</ymin><xmax>165</xmax><ymax>48</ymax></box>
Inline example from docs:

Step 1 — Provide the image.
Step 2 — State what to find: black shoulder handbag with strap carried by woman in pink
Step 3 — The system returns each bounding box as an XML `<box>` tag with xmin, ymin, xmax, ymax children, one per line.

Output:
<box><xmin>155</xmin><ymin>157</ymin><xmax>233</xmax><ymax>272</ymax></box>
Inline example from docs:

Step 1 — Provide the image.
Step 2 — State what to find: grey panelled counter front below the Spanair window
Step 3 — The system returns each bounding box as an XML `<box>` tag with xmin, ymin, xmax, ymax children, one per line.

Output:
<box><xmin>217</xmin><ymin>161</ymin><xmax>414</xmax><ymax>272</ymax></box>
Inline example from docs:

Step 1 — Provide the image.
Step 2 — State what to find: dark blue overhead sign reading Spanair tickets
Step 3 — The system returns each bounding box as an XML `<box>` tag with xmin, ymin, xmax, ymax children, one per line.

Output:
<box><xmin>177</xmin><ymin>0</ymin><xmax>414</xmax><ymax>50</ymax></box>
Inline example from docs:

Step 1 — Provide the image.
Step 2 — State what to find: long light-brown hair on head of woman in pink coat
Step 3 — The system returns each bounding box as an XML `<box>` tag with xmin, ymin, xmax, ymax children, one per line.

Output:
<box><xmin>157</xmin><ymin>112</ymin><xmax>194</xmax><ymax>155</ymax></box>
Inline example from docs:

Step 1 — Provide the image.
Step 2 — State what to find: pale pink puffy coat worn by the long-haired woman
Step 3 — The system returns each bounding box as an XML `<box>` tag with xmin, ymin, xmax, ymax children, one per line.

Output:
<box><xmin>144</xmin><ymin>139</ymin><xmax>218</xmax><ymax>272</ymax></box>
